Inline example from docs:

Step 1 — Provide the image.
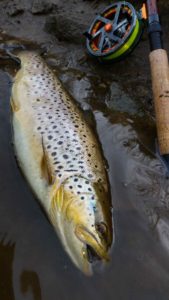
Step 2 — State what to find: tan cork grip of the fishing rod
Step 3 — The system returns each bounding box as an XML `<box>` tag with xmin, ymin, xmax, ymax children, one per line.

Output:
<box><xmin>149</xmin><ymin>49</ymin><xmax>169</xmax><ymax>155</ymax></box>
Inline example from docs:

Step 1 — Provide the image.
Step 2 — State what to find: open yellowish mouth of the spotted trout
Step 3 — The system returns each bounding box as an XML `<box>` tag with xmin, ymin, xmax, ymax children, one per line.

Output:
<box><xmin>75</xmin><ymin>225</ymin><xmax>110</xmax><ymax>263</ymax></box>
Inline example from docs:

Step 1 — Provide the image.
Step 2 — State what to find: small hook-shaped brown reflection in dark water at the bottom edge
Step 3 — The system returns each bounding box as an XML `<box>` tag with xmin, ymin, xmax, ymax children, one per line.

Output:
<box><xmin>20</xmin><ymin>270</ymin><xmax>42</xmax><ymax>300</ymax></box>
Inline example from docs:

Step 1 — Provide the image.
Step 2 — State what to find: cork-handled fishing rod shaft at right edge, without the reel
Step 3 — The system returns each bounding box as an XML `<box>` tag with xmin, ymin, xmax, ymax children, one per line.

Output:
<box><xmin>146</xmin><ymin>0</ymin><xmax>169</xmax><ymax>176</ymax></box>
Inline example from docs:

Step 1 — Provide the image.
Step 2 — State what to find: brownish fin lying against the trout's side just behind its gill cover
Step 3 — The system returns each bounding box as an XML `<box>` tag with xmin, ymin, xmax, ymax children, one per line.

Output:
<box><xmin>41</xmin><ymin>137</ymin><xmax>54</xmax><ymax>185</ymax></box>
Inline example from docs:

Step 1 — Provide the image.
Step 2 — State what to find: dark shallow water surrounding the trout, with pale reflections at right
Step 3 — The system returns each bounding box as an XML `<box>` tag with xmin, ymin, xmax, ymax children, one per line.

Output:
<box><xmin>0</xmin><ymin>45</ymin><xmax>169</xmax><ymax>300</ymax></box>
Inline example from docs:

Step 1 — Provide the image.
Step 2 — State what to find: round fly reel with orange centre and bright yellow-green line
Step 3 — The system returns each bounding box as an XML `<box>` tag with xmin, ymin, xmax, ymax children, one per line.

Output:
<box><xmin>85</xmin><ymin>1</ymin><xmax>143</xmax><ymax>62</ymax></box>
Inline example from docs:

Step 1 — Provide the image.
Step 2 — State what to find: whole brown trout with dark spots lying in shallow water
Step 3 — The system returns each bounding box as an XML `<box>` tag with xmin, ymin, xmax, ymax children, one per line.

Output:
<box><xmin>11</xmin><ymin>51</ymin><xmax>113</xmax><ymax>275</ymax></box>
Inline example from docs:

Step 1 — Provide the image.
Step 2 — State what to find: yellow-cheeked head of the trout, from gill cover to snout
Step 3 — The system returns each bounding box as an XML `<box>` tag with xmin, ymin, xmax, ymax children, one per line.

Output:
<box><xmin>50</xmin><ymin>176</ymin><xmax>112</xmax><ymax>275</ymax></box>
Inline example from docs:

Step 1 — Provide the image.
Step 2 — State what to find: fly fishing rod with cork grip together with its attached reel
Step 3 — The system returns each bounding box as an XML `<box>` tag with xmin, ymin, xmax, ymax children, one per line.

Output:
<box><xmin>84</xmin><ymin>0</ymin><xmax>169</xmax><ymax>175</ymax></box>
